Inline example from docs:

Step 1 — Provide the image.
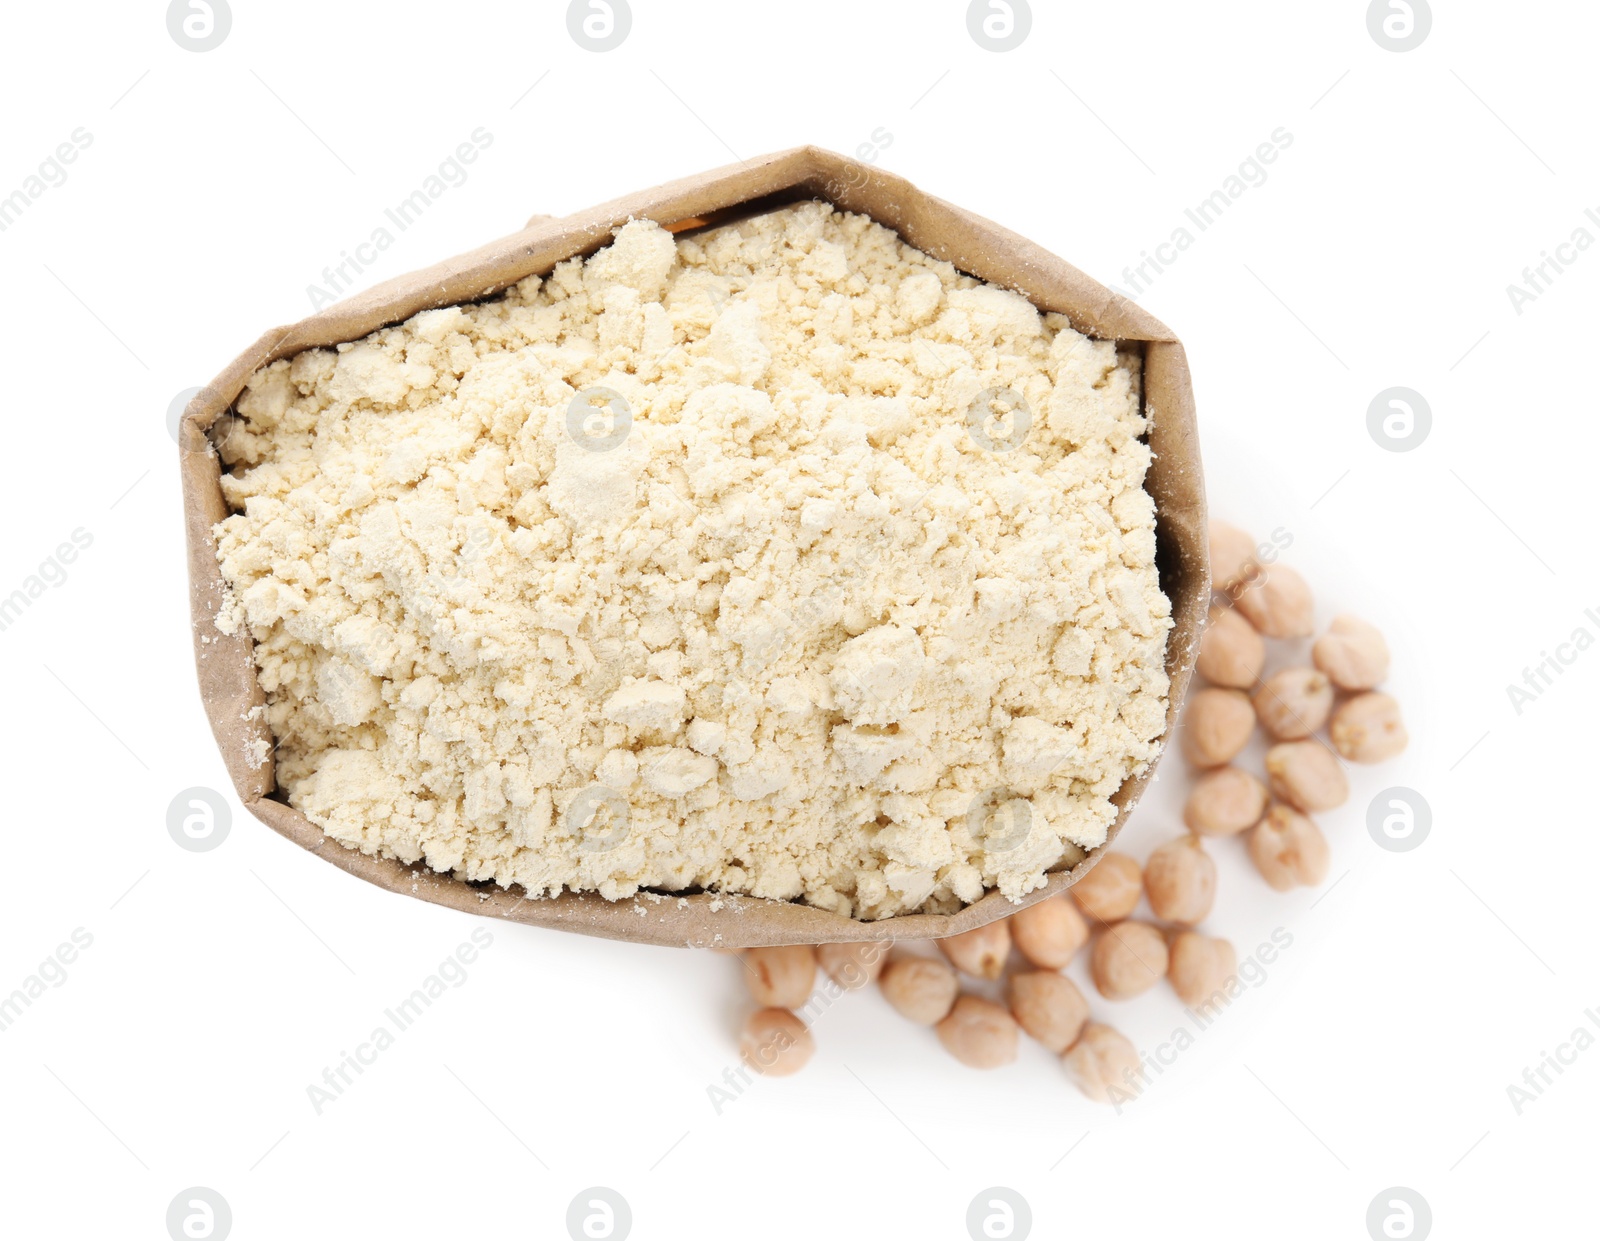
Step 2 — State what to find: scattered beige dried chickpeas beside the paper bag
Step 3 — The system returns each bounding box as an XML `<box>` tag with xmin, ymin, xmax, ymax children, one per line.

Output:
<box><xmin>739</xmin><ymin>525</ymin><xmax>1406</xmax><ymax>1102</ymax></box>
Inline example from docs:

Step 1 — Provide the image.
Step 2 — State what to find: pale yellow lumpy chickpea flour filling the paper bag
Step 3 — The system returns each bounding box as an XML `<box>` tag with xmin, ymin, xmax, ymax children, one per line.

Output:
<box><xmin>216</xmin><ymin>203</ymin><xmax>1171</xmax><ymax>918</ymax></box>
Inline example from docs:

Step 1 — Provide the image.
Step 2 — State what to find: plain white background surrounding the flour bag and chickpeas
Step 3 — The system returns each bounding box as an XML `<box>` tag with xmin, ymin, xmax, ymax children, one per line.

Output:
<box><xmin>0</xmin><ymin>0</ymin><xmax>1600</xmax><ymax>1241</ymax></box>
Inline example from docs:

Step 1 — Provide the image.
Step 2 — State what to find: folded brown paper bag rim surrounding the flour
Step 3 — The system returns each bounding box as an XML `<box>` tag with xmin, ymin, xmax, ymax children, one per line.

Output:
<box><xmin>179</xmin><ymin>147</ymin><xmax>1210</xmax><ymax>947</ymax></box>
